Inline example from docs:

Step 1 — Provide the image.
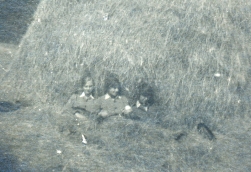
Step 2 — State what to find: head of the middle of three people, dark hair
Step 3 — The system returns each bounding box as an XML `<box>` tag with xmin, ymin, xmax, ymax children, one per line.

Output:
<box><xmin>105</xmin><ymin>74</ymin><xmax>121</xmax><ymax>98</ymax></box>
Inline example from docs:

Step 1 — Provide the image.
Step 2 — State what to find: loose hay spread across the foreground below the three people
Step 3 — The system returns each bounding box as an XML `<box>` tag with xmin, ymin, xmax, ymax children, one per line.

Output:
<box><xmin>0</xmin><ymin>107</ymin><xmax>251</xmax><ymax>171</ymax></box>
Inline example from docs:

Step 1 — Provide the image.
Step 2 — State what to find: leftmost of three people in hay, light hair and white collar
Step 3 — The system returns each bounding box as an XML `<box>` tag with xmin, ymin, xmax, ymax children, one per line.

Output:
<box><xmin>63</xmin><ymin>75</ymin><xmax>97</xmax><ymax>118</ymax></box>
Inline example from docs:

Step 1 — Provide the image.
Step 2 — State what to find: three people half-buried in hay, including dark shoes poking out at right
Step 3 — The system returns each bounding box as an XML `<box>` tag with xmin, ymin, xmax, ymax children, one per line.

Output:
<box><xmin>62</xmin><ymin>72</ymin><xmax>215</xmax><ymax>141</ymax></box>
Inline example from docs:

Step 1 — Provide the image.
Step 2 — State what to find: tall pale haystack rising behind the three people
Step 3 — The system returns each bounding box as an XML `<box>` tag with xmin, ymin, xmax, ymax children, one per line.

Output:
<box><xmin>0</xmin><ymin>0</ymin><xmax>250</xmax><ymax>115</ymax></box>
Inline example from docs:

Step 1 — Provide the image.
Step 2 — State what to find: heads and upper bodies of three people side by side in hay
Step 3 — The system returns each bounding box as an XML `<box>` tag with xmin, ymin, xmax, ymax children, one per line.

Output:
<box><xmin>66</xmin><ymin>72</ymin><xmax>153</xmax><ymax>120</ymax></box>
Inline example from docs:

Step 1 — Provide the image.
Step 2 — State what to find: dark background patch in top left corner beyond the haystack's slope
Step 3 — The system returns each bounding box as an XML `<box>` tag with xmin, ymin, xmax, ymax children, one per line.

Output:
<box><xmin>0</xmin><ymin>0</ymin><xmax>40</xmax><ymax>44</ymax></box>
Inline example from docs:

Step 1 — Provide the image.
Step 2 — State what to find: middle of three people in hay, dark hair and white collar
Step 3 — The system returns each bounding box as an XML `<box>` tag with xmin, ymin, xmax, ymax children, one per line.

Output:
<box><xmin>97</xmin><ymin>74</ymin><xmax>131</xmax><ymax>119</ymax></box>
